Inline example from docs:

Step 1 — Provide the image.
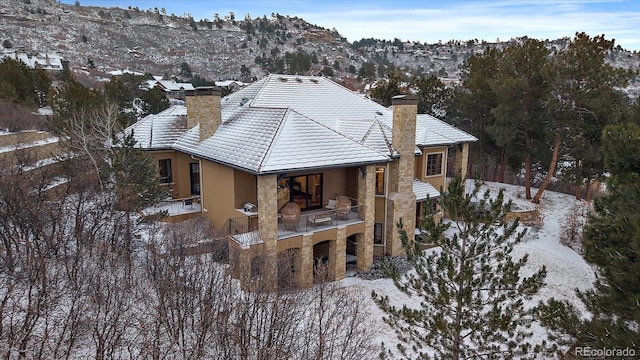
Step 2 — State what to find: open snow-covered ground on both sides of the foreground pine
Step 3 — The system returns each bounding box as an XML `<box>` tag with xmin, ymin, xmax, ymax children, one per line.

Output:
<box><xmin>341</xmin><ymin>182</ymin><xmax>596</xmax><ymax>356</ymax></box>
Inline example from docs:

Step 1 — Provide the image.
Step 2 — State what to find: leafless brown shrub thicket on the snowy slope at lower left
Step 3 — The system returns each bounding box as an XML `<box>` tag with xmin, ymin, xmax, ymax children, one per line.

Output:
<box><xmin>0</xmin><ymin>149</ymin><xmax>375</xmax><ymax>360</ymax></box>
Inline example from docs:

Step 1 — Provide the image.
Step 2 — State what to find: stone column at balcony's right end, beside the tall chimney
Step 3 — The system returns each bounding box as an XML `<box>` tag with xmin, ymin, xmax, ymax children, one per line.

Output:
<box><xmin>356</xmin><ymin>165</ymin><xmax>376</xmax><ymax>270</ymax></box>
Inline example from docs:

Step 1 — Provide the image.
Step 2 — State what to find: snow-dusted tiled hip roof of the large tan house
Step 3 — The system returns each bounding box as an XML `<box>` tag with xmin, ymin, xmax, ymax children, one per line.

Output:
<box><xmin>126</xmin><ymin>75</ymin><xmax>475</xmax><ymax>174</ymax></box>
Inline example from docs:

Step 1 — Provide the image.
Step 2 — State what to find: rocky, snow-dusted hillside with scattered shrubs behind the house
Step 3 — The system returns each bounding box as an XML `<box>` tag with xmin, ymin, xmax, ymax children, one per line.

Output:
<box><xmin>0</xmin><ymin>0</ymin><xmax>640</xmax><ymax>94</ymax></box>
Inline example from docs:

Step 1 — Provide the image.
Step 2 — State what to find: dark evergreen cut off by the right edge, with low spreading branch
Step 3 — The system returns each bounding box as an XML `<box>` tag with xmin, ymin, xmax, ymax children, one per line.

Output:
<box><xmin>543</xmin><ymin>124</ymin><xmax>640</xmax><ymax>350</ymax></box>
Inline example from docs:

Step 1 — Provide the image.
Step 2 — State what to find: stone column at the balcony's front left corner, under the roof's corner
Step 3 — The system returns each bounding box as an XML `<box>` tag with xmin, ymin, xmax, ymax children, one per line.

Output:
<box><xmin>257</xmin><ymin>175</ymin><xmax>278</xmax><ymax>288</ymax></box>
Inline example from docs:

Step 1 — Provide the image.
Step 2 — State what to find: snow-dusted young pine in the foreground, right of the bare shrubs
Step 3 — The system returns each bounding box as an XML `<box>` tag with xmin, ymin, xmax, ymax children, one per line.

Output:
<box><xmin>372</xmin><ymin>177</ymin><xmax>546</xmax><ymax>359</ymax></box>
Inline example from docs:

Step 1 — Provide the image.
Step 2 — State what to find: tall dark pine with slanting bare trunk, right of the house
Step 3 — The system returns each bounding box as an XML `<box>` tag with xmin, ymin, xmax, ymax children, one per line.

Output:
<box><xmin>532</xmin><ymin>33</ymin><xmax>630</xmax><ymax>203</ymax></box>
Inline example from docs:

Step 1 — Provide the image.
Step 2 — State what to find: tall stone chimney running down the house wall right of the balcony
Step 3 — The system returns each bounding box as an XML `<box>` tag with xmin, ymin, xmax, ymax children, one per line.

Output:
<box><xmin>386</xmin><ymin>95</ymin><xmax>418</xmax><ymax>256</ymax></box>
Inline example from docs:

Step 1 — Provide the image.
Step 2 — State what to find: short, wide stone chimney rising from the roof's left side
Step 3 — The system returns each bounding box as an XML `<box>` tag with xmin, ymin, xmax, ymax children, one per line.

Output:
<box><xmin>184</xmin><ymin>86</ymin><xmax>222</xmax><ymax>141</ymax></box>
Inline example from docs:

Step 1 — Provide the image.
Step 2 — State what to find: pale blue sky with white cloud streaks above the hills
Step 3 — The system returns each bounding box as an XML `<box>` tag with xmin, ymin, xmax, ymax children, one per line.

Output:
<box><xmin>61</xmin><ymin>0</ymin><xmax>640</xmax><ymax>50</ymax></box>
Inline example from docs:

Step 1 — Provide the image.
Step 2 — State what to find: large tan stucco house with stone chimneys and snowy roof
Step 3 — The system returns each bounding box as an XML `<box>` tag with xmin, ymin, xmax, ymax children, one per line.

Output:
<box><xmin>126</xmin><ymin>75</ymin><xmax>476</xmax><ymax>286</ymax></box>
